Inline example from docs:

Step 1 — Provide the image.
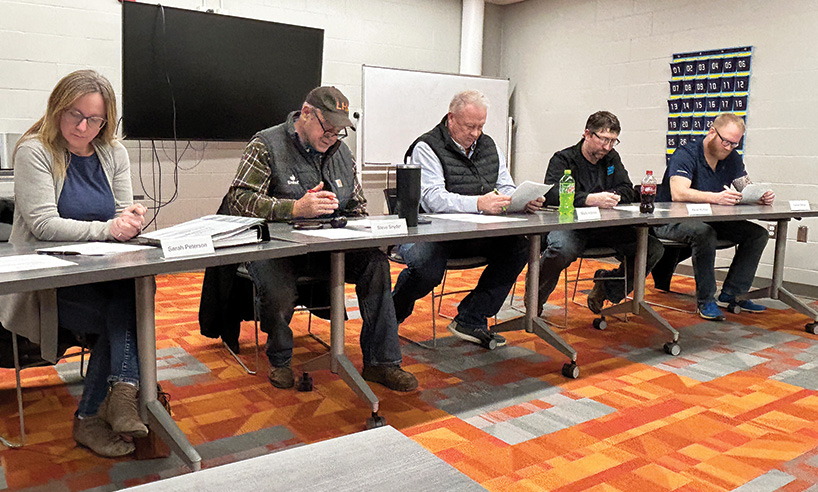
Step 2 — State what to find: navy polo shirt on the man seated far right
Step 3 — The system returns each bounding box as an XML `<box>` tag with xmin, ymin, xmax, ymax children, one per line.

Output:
<box><xmin>656</xmin><ymin>138</ymin><xmax>747</xmax><ymax>202</ymax></box>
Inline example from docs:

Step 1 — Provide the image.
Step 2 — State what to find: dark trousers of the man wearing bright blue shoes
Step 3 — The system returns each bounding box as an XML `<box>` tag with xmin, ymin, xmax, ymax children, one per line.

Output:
<box><xmin>656</xmin><ymin>220</ymin><xmax>767</xmax><ymax>304</ymax></box>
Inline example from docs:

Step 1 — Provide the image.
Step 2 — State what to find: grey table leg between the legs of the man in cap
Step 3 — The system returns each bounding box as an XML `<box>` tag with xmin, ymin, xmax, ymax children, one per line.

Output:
<box><xmin>303</xmin><ymin>252</ymin><xmax>378</xmax><ymax>413</ymax></box>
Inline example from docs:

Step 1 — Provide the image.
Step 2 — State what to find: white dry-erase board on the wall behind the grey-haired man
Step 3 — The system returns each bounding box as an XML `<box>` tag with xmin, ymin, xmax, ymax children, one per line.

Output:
<box><xmin>360</xmin><ymin>65</ymin><xmax>509</xmax><ymax>168</ymax></box>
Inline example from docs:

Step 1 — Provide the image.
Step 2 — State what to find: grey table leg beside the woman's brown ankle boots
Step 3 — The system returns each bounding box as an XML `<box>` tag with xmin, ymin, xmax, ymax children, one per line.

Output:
<box><xmin>135</xmin><ymin>276</ymin><xmax>202</xmax><ymax>471</ymax></box>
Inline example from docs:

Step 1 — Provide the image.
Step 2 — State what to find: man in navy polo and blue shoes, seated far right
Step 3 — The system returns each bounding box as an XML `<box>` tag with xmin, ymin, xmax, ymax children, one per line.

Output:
<box><xmin>656</xmin><ymin>113</ymin><xmax>775</xmax><ymax>321</ymax></box>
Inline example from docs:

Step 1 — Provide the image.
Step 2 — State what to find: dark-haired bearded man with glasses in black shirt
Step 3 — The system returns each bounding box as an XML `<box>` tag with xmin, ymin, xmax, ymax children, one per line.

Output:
<box><xmin>537</xmin><ymin>111</ymin><xmax>664</xmax><ymax>313</ymax></box>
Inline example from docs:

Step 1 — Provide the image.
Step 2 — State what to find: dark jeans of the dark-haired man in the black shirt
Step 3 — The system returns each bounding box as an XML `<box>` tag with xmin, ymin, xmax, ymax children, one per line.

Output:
<box><xmin>539</xmin><ymin>226</ymin><xmax>665</xmax><ymax>307</ymax></box>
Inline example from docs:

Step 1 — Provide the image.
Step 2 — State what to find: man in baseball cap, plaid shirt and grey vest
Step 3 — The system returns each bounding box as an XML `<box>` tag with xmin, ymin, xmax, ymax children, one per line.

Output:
<box><xmin>207</xmin><ymin>87</ymin><xmax>417</xmax><ymax>391</ymax></box>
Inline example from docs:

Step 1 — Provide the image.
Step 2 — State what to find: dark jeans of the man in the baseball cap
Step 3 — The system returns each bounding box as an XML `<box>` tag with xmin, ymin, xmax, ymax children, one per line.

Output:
<box><xmin>247</xmin><ymin>249</ymin><xmax>401</xmax><ymax>367</ymax></box>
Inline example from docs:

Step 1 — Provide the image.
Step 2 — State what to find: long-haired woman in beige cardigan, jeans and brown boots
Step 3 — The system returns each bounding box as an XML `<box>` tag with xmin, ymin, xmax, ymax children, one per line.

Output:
<box><xmin>0</xmin><ymin>70</ymin><xmax>148</xmax><ymax>457</ymax></box>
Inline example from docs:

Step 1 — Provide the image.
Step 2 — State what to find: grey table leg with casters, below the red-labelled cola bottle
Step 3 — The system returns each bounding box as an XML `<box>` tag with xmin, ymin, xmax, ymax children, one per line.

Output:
<box><xmin>599</xmin><ymin>225</ymin><xmax>679</xmax><ymax>348</ymax></box>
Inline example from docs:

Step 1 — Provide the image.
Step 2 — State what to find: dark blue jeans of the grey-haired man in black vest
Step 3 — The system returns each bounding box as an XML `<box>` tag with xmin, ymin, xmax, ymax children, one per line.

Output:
<box><xmin>392</xmin><ymin>236</ymin><xmax>528</xmax><ymax>329</ymax></box>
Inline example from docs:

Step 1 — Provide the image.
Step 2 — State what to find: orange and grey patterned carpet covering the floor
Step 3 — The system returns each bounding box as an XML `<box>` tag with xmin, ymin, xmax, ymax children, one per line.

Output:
<box><xmin>0</xmin><ymin>262</ymin><xmax>818</xmax><ymax>492</ymax></box>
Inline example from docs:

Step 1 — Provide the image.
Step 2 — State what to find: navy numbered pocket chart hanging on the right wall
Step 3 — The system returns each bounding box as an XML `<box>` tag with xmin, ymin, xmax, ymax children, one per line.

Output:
<box><xmin>667</xmin><ymin>46</ymin><xmax>753</xmax><ymax>165</ymax></box>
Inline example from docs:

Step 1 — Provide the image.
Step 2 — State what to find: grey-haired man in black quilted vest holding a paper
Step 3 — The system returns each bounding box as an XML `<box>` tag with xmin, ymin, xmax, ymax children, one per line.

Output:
<box><xmin>392</xmin><ymin>91</ymin><xmax>543</xmax><ymax>347</ymax></box>
